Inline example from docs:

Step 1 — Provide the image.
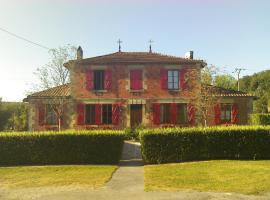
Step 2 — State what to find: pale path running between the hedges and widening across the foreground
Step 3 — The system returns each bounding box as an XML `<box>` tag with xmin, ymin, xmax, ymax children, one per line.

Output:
<box><xmin>0</xmin><ymin>141</ymin><xmax>270</xmax><ymax>200</ymax></box>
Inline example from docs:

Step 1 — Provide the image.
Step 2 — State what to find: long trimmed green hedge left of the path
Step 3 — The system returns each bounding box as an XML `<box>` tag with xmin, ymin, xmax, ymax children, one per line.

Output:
<box><xmin>0</xmin><ymin>130</ymin><xmax>124</xmax><ymax>165</ymax></box>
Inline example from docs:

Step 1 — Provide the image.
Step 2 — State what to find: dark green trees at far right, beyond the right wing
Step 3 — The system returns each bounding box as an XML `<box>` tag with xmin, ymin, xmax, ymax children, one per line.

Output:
<box><xmin>240</xmin><ymin>70</ymin><xmax>270</xmax><ymax>113</ymax></box>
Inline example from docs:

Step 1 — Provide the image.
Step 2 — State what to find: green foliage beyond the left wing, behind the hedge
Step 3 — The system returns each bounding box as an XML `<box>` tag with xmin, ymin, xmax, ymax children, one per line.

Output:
<box><xmin>0</xmin><ymin>102</ymin><xmax>28</xmax><ymax>131</ymax></box>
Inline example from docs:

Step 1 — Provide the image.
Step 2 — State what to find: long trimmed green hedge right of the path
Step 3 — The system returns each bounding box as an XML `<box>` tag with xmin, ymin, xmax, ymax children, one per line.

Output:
<box><xmin>140</xmin><ymin>126</ymin><xmax>270</xmax><ymax>164</ymax></box>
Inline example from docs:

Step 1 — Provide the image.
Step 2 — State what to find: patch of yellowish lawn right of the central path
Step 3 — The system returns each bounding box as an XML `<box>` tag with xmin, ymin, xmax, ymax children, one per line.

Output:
<box><xmin>144</xmin><ymin>160</ymin><xmax>270</xmax><ymax>194</ymax></box>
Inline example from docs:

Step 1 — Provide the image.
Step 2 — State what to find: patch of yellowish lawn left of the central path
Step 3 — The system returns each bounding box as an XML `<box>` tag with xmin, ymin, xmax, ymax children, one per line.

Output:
<box><xmin>0</xmin><ymin>165</ymin><xmax>117</xmax><ymax>188</ymax></box>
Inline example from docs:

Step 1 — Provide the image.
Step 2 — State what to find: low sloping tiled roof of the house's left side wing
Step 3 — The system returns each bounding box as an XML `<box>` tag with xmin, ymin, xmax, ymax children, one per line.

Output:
<box><xmin>27</xmin><ymin>83</ymin><xmax>70</xmax><ymax>98</ymax></box>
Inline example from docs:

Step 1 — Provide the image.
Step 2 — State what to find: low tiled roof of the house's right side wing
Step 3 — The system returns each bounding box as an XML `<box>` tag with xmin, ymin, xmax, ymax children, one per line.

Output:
<box><xmin>204</xmin><ymin>85</ymin><xmax>255</xmax><ymax>97</ymax></box>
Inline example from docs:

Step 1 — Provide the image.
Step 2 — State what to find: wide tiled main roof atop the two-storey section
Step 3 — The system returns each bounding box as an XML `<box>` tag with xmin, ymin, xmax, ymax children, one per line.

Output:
<box><xmin>70</xmin><ymin>52</ymin><xmax>206</xmax><ymax>66</ymax></box>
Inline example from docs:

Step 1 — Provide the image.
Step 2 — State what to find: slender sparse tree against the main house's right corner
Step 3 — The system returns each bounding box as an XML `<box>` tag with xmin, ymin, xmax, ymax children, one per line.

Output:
<box><xmin>186</xmin><ymin>65</ymin><xmax>220</xmax><ymax>126</ymax></box>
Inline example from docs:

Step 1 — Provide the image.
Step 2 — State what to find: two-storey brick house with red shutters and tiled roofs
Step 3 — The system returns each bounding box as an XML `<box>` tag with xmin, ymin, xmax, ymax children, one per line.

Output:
<box><xmin>26</xmin><ymin>47</ymin><xmax>254</xmax><ymax>130</ymax></box>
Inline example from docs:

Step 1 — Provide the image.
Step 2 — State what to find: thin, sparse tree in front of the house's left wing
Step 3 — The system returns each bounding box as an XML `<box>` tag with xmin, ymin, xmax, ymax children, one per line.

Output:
<box><xmin>31</xmin><ymin>45</ymin><xmax>76</xmax><ymax>131</ymax></box>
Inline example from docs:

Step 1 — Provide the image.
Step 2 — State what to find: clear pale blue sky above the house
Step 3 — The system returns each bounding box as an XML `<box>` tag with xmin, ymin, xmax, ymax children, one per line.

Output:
<box><xmin>0</xmin><ymin>0</ymin><xmax>270</xmax><ymax>101</ymax></box>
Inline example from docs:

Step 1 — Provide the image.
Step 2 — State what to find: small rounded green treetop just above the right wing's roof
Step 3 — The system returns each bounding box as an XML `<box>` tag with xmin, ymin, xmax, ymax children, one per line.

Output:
<box><xmin>214</xmin><ymin>74</ymin><xmax>237</xmax><ymax>90</ymax></box>
